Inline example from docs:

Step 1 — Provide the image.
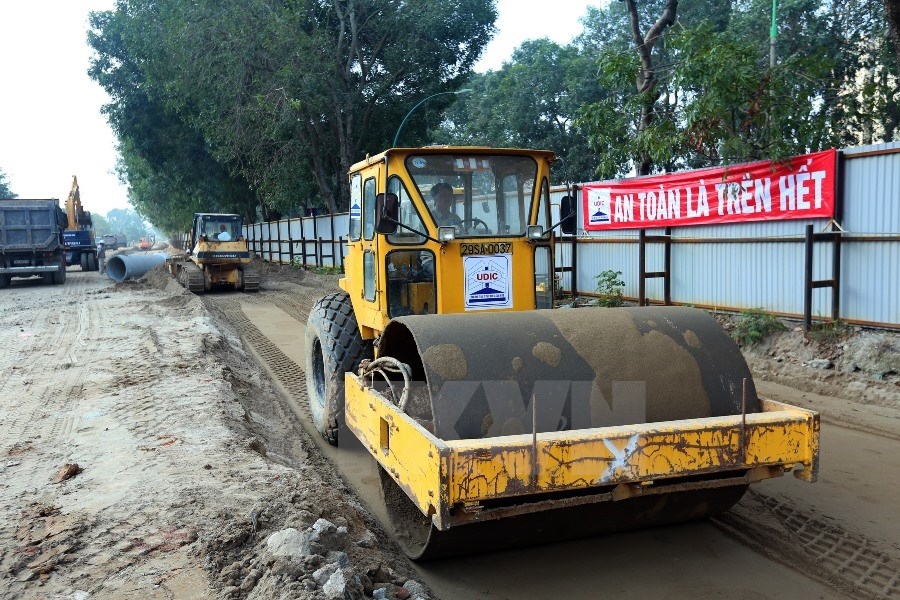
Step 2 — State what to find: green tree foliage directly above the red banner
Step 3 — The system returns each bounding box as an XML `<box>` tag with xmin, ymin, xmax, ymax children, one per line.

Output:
<box><xmin>579</xmin><ymin>0</ymin><xmax>898</xmax><ymax>177</ymax></box>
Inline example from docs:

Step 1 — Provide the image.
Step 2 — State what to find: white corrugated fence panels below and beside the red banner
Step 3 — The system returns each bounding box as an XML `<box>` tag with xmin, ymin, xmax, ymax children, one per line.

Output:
<box><xmin>553</xmin><ymin>143</ymin><xmax>900</xmax><ymax>327</ymax></box>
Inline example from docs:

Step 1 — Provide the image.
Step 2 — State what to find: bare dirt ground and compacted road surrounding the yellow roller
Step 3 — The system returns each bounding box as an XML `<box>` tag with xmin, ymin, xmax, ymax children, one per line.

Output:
<box><xmin>0</xmin><ymin>268</ymin><xmax>900</xmax><ymax>599</ymax></box>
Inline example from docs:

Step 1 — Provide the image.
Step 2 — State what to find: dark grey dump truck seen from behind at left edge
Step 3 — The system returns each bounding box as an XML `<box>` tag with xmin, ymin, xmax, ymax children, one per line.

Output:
<box><xmin>0</xmin><ymin>198</ymin><xmax>68</xmax><ymax>288</ymax></box>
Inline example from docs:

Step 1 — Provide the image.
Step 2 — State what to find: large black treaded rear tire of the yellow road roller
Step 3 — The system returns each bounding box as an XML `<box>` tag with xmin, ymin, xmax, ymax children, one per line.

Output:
<box><xmin>305</xmin><ymin>292</ymin><xmax>373</xmax><ymax>446</ymax></box>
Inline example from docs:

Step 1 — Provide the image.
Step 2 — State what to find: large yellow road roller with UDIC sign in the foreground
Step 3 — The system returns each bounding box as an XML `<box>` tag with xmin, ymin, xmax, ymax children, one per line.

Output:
<box><xmin>305</xmin><ymin>147</ymin><xmax>819</xmax><ymax>559</ymax></box>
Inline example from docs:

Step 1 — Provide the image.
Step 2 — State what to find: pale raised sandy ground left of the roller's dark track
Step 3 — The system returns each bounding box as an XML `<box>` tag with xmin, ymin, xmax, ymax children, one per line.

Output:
<box><xmin>0</xmin><ymin>270</ymin><xmax>427</xmax><ymax>599</ymax></box>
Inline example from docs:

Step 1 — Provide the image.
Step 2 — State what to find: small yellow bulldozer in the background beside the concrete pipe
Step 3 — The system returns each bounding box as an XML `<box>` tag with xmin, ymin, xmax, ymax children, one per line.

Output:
<box><xmin>167</xmin><ymin>213</ymin><xmax>259</xmax><ymax>294</ymax></box>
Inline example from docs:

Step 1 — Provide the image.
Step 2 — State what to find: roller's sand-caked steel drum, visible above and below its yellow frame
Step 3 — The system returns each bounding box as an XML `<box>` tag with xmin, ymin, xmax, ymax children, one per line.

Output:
<box><xmin>364</xmin><ymin>307</ymin><xmax>759</xmax><ymax>558</ymax></box>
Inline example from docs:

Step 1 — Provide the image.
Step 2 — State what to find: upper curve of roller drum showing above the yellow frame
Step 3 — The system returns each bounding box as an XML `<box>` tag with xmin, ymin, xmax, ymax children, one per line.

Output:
<box><xmin>379</xmin><ymin>307</ymin><xmax>759</xmax><ymax>440</ymax></box>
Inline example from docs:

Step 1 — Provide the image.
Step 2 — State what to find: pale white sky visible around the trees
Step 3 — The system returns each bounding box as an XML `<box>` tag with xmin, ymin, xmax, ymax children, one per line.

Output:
<box><xmin>0</xmin><ymin>0</ymin><xmax>604</xmax><ymax>215</ymax></box>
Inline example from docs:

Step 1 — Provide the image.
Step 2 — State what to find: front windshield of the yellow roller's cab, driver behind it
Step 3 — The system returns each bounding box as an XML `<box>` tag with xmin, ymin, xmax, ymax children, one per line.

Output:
<box><xmin>406</xmin><ymin>153</ymin><xmax>537</xmax><ymax>237</ymax></box>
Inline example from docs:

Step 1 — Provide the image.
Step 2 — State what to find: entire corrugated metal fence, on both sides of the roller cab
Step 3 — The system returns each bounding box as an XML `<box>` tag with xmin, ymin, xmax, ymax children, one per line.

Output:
<box><xmin>245</xmin><ymin>143</ymin><xmax>900</xmax><ymax>329</ymax></box>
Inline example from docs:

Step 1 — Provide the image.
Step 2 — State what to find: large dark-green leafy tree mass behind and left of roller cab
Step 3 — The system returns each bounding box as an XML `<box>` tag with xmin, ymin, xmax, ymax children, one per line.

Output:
<box><xmin>91</xmin><ymin>0</ymin><xmax>496</xmax><ymax>226</ymax></box>
